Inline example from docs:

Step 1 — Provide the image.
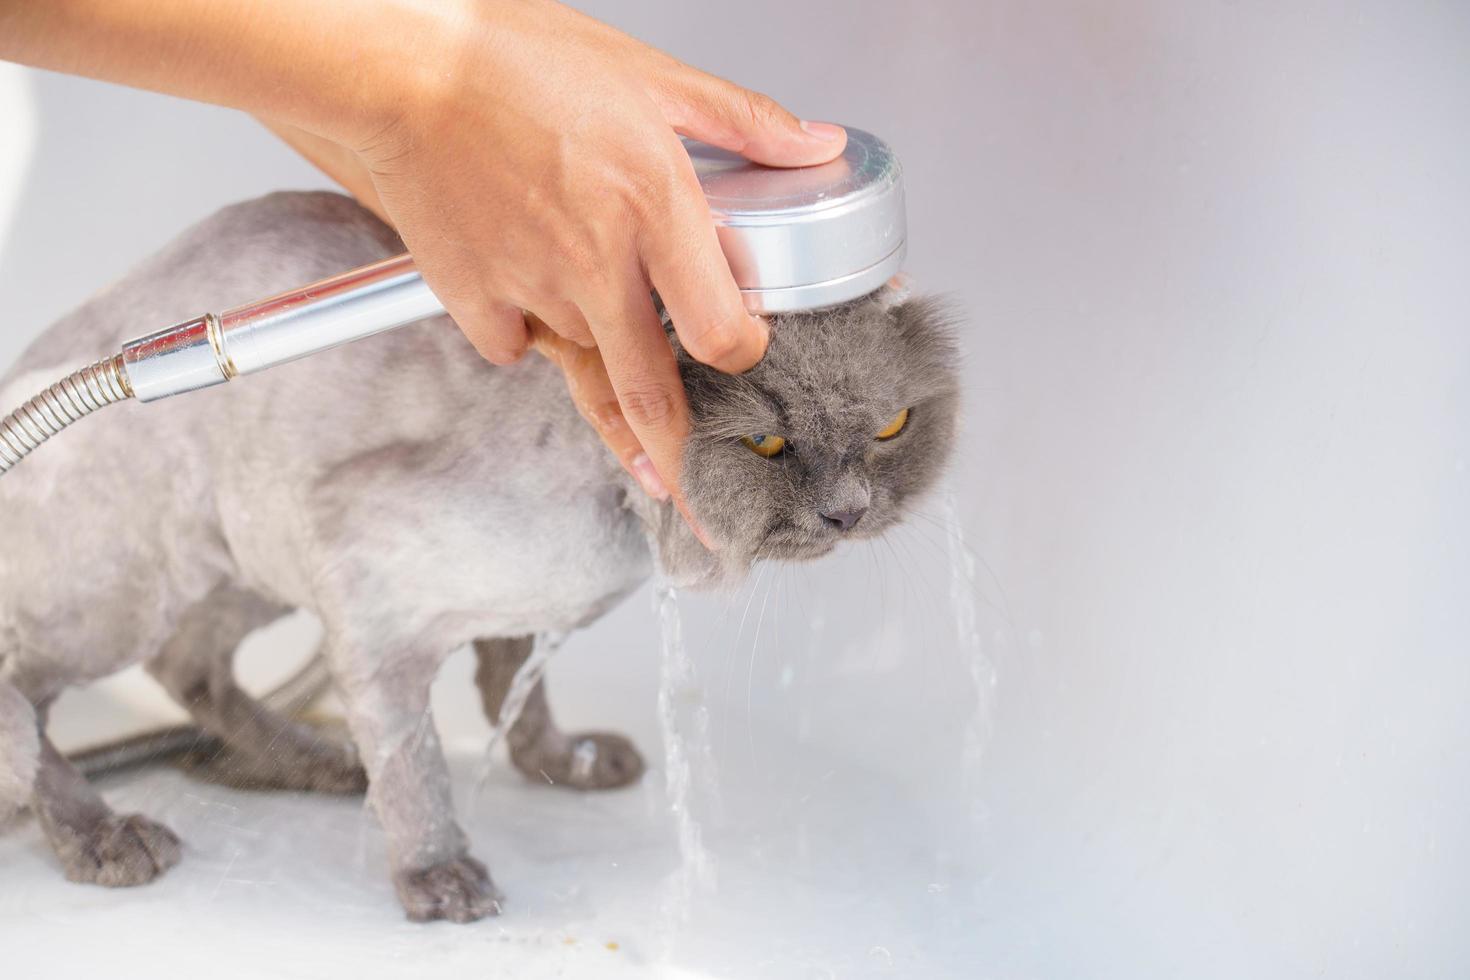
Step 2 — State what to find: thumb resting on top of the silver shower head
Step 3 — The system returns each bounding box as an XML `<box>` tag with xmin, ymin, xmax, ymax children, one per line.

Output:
<box><xmin>653</xmin><ymin>66</ymin><xmax>847</xmax><ymax>166</ymax></box>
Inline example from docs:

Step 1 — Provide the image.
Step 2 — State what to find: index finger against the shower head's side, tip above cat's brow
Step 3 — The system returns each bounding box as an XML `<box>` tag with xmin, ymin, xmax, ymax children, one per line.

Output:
<box><xmin>644</xmin><ymin>172</ymin><xmax>770</xmax><ymax>373</ymax></box>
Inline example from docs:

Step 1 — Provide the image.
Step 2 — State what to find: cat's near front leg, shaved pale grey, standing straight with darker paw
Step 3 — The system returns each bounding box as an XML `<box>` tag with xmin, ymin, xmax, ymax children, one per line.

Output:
<box><xmin>328</xmin><ymin>632</ymin><xmax>501</xmax><ymax>923</ymax></box>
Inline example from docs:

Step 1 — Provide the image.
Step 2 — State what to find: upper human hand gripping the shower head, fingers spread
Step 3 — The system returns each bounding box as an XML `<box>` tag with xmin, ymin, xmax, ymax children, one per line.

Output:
<box><xmin>326</xmin><ymin>0</ymin><xmax>845</xmax><ymax>528</ymax></box>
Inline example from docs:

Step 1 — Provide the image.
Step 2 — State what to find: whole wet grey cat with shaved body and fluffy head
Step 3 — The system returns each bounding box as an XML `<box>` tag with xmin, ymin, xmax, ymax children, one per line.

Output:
<box><xmin>0</xmin><ymin>194</ymin><xmax>958</xmax><ymax>921</ymax></box>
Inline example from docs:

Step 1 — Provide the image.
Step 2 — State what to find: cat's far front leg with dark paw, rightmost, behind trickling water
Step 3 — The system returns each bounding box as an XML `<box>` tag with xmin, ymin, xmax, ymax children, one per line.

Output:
<box><xmin>475</xmin><ymin>636</ymin><xmax>644</xmax><ymax>789</ymax></box>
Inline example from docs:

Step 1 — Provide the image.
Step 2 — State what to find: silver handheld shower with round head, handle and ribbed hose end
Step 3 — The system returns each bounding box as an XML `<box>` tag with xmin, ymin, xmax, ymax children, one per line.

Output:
<box><xmin>0</xmin><ymin>129</ymin><xmax>906</xmax><ymax>473</ymax></box>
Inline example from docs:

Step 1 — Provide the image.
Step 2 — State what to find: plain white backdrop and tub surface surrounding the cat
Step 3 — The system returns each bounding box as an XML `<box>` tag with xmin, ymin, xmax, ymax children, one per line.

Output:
<box><xmin>0</xmin><ymin>0</ymin><xmax>1470</xmax><ymax>979</ymax></box>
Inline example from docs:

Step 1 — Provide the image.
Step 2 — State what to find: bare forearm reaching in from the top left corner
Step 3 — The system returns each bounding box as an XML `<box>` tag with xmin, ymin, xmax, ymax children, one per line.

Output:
<box><xmin>0</xmin><ymin>0</ymin><xmax>460</xmax><ymax>145</ymax></box>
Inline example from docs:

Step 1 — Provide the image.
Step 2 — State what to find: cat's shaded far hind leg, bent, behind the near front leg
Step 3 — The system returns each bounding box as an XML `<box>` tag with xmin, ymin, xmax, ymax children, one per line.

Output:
<box><xmin>147</xmin><ymin>585</ymin><xmax>368</xmax><ymax>793</ymax></box>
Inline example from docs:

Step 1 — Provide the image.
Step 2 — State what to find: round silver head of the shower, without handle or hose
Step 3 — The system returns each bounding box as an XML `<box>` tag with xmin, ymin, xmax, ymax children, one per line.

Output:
<box><xmin>685</xmin><ymin>128</ymin><xmax>907</xmax><ymax>313</ymax></box>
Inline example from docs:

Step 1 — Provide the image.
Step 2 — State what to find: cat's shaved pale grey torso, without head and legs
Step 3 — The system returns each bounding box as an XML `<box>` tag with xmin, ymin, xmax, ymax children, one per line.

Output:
<box><xmin>0</xmin><ymin>194</ymin><xmax>645</xmax><ymax>646</ymax></box>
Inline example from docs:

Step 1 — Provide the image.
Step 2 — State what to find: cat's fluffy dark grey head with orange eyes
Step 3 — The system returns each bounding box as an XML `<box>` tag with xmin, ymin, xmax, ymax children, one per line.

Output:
<box><xmin>679</xmin><ymin>287</ymin><xmax>960</xmax><ymax>566</ymax></box>
